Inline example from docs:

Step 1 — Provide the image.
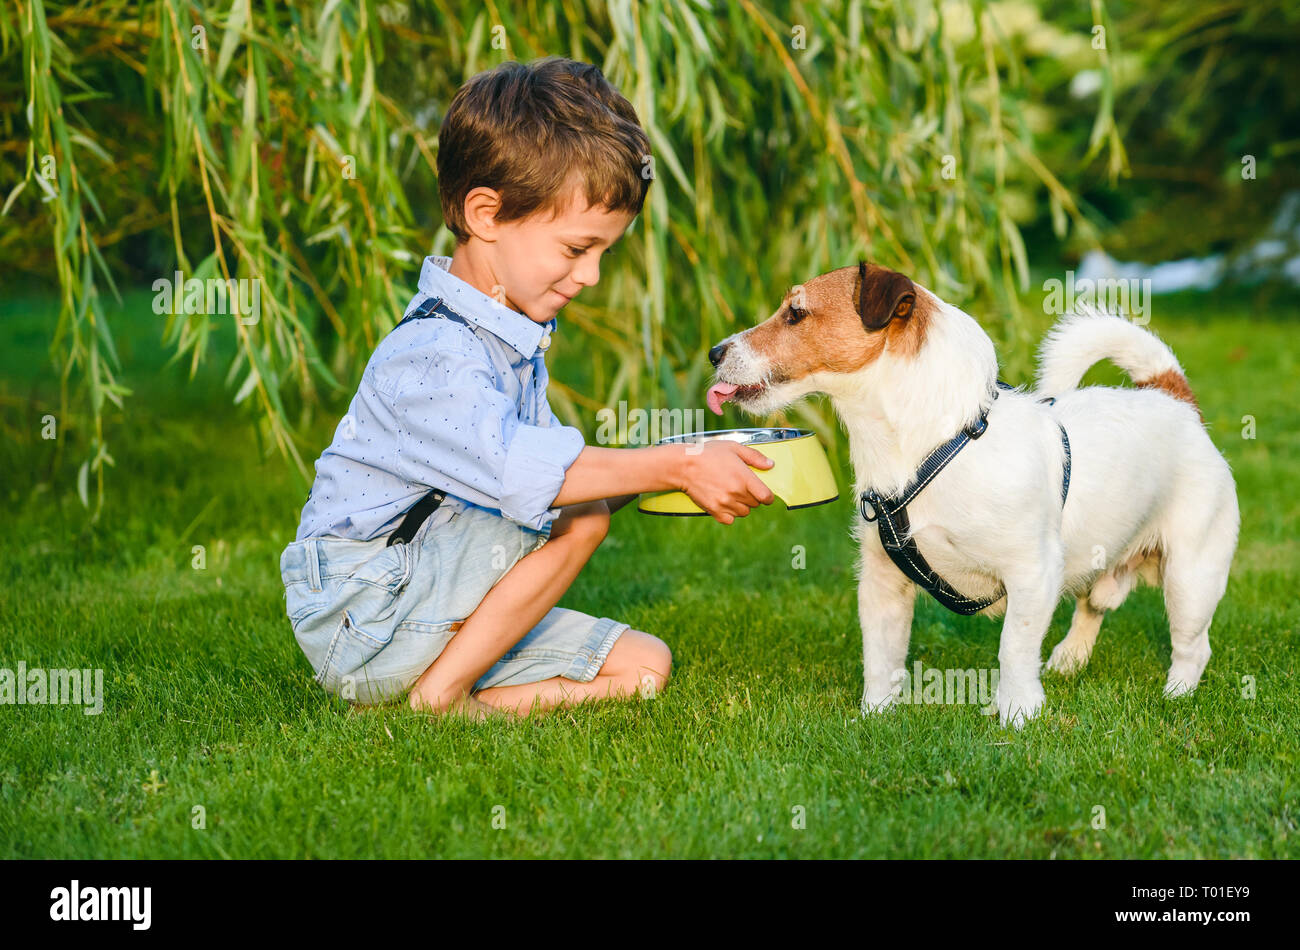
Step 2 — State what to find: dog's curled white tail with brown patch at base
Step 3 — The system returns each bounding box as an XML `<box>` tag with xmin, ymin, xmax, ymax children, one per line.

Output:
<box><xmin>1037</xmin><ymin>302</ymin><xmax>1200</xmax><ymax>413</ymax></box>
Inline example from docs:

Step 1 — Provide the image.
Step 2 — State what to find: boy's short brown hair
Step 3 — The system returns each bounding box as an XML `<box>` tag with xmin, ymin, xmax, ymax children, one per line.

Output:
<box><xmin>438</xmin><ymin>56</ymin><xmax>653</xmax><ymax>243</ymax></box>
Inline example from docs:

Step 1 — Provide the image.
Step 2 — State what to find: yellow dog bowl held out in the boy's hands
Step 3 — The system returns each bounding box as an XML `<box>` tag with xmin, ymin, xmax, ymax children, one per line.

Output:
<box><xmin>637</xmin><ymin>429</ymin><xmax>840</xmax><ymax>515</ymax></box>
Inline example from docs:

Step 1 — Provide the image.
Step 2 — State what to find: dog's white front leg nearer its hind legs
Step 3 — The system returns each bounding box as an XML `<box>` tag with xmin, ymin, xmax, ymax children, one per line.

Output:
<box><xmin>997</xmin><ymin>548</ymin><xmax>1065</xmax><ymax>729</ymax></box>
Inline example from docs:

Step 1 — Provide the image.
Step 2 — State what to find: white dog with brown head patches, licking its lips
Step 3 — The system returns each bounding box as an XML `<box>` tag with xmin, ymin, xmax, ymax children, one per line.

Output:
<box><xmin>709</xmin><ymin>264</ymin><xmax>1239</xmax><ymax>726</ymax></box>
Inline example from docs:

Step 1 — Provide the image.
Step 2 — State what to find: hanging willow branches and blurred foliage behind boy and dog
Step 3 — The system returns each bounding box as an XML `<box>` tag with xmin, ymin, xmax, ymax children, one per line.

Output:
<box><xmin>0</xmin><ymin>0</ymin><xmax>1300</xmax><ymax>513</ymax></box>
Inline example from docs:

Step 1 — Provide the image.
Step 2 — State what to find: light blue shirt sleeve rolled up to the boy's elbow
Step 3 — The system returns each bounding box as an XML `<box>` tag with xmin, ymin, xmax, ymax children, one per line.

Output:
<box><xmin>391</xmin><ymin>348</ymin><xmax>585</xmax><ymax>530</ymax></box>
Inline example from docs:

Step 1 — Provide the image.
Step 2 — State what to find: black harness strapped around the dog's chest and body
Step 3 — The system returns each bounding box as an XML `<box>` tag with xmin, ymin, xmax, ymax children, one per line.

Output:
<box><xmin>858</xmin><ymin>379</ymin><xmax>1070</xmax><ymax>616</ymax></box>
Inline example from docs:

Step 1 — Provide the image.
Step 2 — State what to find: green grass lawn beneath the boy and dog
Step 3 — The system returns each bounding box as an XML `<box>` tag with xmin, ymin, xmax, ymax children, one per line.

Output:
<box><xmin>0</xmin><ymin>285</ymin><xmax>1300</xmax><ymax>858</ymax></box>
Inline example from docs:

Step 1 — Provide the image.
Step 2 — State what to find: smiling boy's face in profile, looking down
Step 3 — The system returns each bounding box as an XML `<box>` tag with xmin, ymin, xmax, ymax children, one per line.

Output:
<box><xmin>488</xmin><ymin>188</ymin><xmax>636</xmax><ymax>324</ymax></box>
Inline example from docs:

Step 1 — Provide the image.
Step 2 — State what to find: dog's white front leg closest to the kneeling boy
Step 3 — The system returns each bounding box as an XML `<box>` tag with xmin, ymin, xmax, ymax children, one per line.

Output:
<box><xmin>858</xmin><ymin>541</ymin><xmax>917</xmax><ymax>716</ymax></box>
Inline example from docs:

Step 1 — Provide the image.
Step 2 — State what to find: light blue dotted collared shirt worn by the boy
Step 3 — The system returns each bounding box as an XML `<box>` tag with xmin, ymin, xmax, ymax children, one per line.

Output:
<box><xmin>296</xmin><ymin>257</ymin><xmax>585</xmax><ymax>541</ymax></box>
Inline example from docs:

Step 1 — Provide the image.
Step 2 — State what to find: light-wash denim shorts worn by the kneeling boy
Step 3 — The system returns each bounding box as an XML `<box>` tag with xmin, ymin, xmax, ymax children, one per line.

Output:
<box><xmin>280</xmin><ymin>504</ymin><xmax>628</xmax><ymax>704</ymax></box>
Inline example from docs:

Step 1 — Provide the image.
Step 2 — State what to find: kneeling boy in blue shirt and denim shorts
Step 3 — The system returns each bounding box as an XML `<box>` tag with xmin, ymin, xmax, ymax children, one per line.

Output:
<box><xmin>281</xmin><ymin>58</ymin><xmax>774</xmax><ymax>717</ymax></box>
